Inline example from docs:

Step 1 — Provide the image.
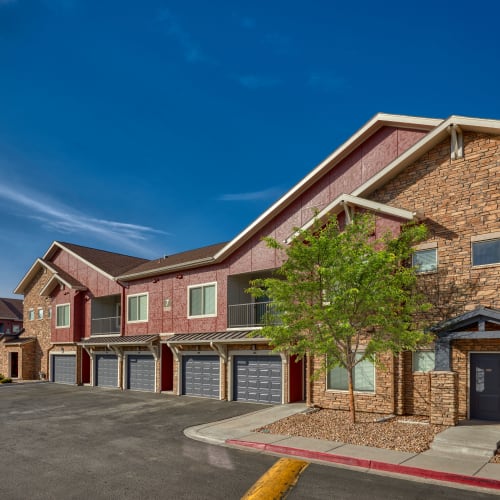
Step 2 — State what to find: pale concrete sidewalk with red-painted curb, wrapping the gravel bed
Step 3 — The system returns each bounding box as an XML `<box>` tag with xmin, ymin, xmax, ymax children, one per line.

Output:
<box><xmin>184</xmin><ymin>403</ymin><xmax>500</xmax><ymax>493</ymax></box>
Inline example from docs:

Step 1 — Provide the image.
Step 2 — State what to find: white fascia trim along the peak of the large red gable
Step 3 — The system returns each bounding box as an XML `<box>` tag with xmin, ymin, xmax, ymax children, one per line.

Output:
<box><xmin>214</xmin><ymin>113</ymin><xmax>443</xmax><ymax>260</ymax></box>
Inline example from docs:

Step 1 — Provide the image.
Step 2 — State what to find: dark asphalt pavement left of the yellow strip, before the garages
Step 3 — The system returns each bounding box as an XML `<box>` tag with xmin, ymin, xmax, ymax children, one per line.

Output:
<box><xmin>0</xmin><ymin>383</ymin><xmax>275</xmax><ymax>500</ymax></box>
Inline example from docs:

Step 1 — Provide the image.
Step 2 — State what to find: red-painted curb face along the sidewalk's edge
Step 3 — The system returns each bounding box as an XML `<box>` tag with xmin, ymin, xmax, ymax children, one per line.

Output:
<box><xmin>226</xmin><ymin>439</ymin><xmax>500</xmax><ymax>490</ymax></box>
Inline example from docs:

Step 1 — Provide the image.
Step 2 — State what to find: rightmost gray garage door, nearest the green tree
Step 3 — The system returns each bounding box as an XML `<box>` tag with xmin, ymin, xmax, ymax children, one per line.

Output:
<box><xmin>233</xmin><ymin>356</ymin><xmax>282</xmax><ymax>404</ymax></box>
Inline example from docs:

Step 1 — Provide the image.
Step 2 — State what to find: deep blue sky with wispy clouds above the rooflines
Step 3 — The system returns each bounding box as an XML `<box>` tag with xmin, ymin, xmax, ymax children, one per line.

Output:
<box><xmin>0</xmin><ymin>0</ymin><xmax>500</xmax><ymax>297</ymax></box>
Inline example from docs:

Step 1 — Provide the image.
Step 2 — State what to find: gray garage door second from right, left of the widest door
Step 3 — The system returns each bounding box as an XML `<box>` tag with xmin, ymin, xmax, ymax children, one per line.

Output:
<box><xmin>182</xmin><ymin>356</ymin><xmax>220</xmax><ymax>399</ymax></box>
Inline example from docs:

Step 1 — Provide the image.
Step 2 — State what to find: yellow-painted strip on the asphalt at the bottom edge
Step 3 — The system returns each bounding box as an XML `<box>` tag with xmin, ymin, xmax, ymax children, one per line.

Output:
<box><xmin>241</xmin><ymin>458</ymin><xmax>309</xmax><ymax>500</ymax></box>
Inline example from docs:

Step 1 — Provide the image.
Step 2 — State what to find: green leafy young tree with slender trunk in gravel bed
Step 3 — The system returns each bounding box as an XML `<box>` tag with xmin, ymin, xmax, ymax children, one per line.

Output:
<box><xmin>247</xmin><ymin>214</ymin><xmax>430</xmax><ymax>422</ymax></box>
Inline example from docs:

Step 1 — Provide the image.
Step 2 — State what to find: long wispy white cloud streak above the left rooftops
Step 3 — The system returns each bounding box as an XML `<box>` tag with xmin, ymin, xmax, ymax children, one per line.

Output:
<box><xmin>0</xmin><ymin>184</ymin><xmax>168</xmax><ymax>253</ymax></box>
